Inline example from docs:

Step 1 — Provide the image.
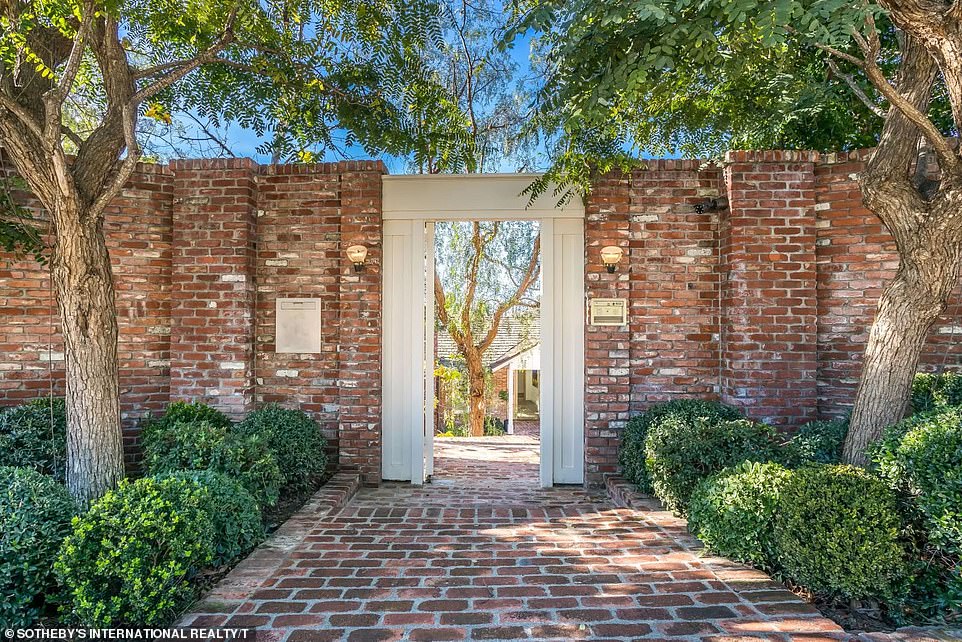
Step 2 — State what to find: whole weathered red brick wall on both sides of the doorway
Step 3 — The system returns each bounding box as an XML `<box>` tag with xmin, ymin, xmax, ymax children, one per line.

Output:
<box><xmin>0</xmin><ymin>152</ymin><xmax>962</xmax><ymax>484</ymax></box>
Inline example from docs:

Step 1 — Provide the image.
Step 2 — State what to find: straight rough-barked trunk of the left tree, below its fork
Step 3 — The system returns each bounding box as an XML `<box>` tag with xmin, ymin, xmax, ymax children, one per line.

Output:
<box><xmin>53</xmin><ymin>197</ymin><xmax>124</xmax><ymax>505</ymax></box>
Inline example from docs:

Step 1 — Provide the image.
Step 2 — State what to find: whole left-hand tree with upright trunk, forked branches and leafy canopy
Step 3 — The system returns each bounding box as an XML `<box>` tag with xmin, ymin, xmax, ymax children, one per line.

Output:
<box><xmin>0</xmin><ymin>0</ymin><xmax>436</xmax><ymax>501</ymax></box>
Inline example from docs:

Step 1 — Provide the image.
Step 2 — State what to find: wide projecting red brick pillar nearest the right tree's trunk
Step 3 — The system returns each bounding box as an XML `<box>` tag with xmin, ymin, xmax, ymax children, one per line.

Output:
<box><xmin>719</xmin><ymin>152</ymin><xmax>818</xmax><ymax>426</ymax></box>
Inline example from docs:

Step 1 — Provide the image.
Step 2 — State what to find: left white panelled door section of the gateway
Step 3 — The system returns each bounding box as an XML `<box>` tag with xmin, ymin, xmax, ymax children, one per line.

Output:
<box><xmin>381</xmin><ymin>220</ymin><xmax>434</xmax><ymax>484</ymax></box>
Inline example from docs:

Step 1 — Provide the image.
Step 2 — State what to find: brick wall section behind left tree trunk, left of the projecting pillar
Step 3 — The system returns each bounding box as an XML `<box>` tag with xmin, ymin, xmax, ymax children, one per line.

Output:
<box><xmin>0</xmin><ymin>165</ymin><xmax>173</xmax><ymax>464</ymax></box>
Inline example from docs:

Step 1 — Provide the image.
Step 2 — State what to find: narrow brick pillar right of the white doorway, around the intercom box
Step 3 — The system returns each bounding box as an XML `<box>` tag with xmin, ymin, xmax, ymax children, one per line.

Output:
<box><xmin>585</xmin><ymin>171</ymin><xmax>632</xmax><ymax>487</ymax></box>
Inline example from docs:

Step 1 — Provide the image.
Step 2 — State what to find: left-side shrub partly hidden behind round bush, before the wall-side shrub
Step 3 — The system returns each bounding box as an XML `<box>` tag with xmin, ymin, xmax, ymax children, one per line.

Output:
<box><xmin>143</xmin><ymin>421</ymin><xmax>283</xmax><ymax>506</ymax></box>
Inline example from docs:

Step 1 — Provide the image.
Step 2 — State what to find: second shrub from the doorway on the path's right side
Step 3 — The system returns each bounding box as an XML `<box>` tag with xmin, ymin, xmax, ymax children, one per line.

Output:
<box><xmin>645</xmin><ymin>415</ymin><xmax>777</xmax><ymax>514</ymax></box>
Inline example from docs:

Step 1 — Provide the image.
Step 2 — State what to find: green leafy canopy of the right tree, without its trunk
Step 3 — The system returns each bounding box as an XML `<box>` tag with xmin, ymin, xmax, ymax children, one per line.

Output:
<box><xmin>507</xmin><ymin>0</ymin><xmax>953</xmax><ymax>194</ymax></box>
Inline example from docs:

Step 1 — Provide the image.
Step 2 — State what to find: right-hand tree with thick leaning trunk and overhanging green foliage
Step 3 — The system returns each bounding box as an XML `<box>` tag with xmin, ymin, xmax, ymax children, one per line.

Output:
<box><xmin>506</xmin><ymin>0</ymin><xmax>962</xmax><ymax>463</ymax></box>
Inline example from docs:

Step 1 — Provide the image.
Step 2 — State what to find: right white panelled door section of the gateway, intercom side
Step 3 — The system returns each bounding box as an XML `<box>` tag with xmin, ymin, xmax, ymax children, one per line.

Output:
<box><xmin>541</xmin><ymin>219</ymin><xmax>585</xmax><ymax>486</ymax></box>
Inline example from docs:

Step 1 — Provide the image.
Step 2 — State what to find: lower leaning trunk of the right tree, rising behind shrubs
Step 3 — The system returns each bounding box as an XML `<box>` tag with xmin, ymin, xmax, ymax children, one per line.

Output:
<box><xmin>843</xmin><ymin>235</ymin><xmax>962</xmax><ymax>465</ymax></box>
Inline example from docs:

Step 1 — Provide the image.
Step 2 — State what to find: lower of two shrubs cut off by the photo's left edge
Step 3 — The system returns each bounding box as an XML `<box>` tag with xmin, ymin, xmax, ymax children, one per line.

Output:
<box><xmin>0</xmin><ymin>466</ymin><xmax>77</xmax><ymax>628</ymax></box>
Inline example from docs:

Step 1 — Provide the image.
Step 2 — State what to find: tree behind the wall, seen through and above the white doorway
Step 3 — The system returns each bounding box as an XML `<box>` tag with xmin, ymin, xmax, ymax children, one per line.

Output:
<box><xmin>396</xmin><ymin>0</ymin><xmax>540</xmax><ymax>436</ymax></box>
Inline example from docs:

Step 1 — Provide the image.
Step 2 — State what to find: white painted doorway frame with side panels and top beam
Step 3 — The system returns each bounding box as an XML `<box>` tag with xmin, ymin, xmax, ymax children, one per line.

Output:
<box><xmin>382</xmin><ymin>174</ymin><xmax>585</xmax><ymax>487</ymax></box>
